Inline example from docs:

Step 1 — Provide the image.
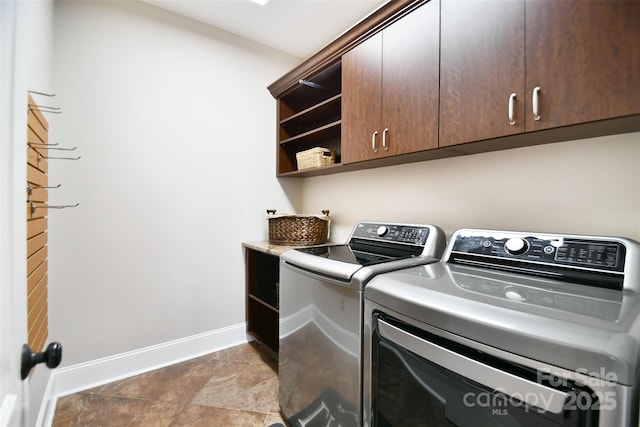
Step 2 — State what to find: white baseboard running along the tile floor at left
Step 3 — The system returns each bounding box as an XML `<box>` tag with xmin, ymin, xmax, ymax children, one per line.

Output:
<box><xmin>36</xmin><ymin>323</ymin><xmax>251</xmax><ymax>426</ymax></box>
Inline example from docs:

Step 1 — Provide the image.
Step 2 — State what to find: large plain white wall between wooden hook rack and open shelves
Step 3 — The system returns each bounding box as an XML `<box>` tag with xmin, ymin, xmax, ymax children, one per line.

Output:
<box><xmin>49</xmin><ymin>1</ymin><xmax>300</xmax><ymax>366</ymax></box>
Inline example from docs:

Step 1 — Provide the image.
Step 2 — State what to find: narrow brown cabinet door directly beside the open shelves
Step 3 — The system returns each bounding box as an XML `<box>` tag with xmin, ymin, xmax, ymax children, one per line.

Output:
<box><xmin>342</xmin><ymin>33</ymin><xmax>382</xmax><ymax>163</ymax></box>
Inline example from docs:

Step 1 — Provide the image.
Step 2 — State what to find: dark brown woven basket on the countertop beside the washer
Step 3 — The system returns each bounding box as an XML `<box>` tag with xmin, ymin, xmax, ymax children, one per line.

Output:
<box><xmin>267</xmin><ymin>209</ymin><xmax>331</xmax><ymax>246</ymax></box>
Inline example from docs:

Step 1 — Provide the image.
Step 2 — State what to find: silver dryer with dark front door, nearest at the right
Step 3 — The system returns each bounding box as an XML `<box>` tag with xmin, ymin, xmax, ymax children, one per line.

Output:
<box><xmin>363</xmin><ymin>229</ymin><xmax>640</xmax><ymax>427</ymax></box>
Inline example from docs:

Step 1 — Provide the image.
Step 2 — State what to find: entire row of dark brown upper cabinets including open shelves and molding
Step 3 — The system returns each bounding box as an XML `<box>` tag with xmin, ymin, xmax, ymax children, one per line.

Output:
<box><xmin>269</xmin><ymin>0</ymin><xmax>640</xmax><ymax>177</ymax></box>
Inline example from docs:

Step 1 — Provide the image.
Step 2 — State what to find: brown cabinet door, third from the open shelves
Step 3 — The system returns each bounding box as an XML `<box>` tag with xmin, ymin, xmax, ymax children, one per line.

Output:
<box><xmin>440</xmin><ymin>0</ymin><xmax>524</xmax><ymax>146</ymax></box>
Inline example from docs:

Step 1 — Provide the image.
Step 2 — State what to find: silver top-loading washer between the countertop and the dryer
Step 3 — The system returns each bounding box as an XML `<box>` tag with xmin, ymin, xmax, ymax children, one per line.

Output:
<box><xmin>279</xmin><ymin>221</ymin><xmax>446</xmax><ymax>427</ymax></box>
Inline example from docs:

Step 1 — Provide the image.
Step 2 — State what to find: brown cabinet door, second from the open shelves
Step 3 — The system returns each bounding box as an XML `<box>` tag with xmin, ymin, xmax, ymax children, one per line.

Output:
<box><xmin>380</xmin><ymin>0</ymin><xmax>440</xmax><ymax>156</ymax></box>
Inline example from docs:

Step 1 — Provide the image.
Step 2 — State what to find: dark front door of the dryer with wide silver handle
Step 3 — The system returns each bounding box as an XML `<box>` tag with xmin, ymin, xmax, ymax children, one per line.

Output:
<box><xmin>372</xmin><ymin>314</ymin><xmax>599</xmax><ymax>427</ymax></box>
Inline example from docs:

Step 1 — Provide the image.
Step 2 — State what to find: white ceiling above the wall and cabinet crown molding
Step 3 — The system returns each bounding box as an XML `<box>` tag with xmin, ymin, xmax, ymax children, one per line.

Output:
<box><xmin>143</xmin><ymin>0</ymin><xmax>387</xmax><ymax>58</ymax></box>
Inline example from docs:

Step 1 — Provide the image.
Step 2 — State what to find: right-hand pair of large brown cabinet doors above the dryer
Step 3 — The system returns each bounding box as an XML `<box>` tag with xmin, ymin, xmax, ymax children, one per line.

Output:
<box><xmin>440</xmin><ymin>0</ymin><xmax>640</xmax><ymax>147</ymax></box>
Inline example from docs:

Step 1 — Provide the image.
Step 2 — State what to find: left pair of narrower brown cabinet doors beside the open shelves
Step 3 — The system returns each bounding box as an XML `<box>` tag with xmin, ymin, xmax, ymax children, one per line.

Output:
<box><xmin>342</xmin><ymin>0</ymin><xmax>439</xmax><ymax>163</ymax></box>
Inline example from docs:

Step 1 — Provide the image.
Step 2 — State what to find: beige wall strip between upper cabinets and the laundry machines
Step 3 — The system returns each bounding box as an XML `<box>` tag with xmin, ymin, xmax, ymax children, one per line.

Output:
<box><xmin>302</xmin><ymin>133</ymin><xmax>640</xmax><ymax>246</ymax></box>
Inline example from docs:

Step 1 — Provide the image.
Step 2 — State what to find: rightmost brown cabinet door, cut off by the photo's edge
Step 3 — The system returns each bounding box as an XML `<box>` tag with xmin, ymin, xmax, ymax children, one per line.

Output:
<box><xmin>526</xmin><ymin>0</ymin><xmax>640</xmax><ymax>131</ymax></box>
